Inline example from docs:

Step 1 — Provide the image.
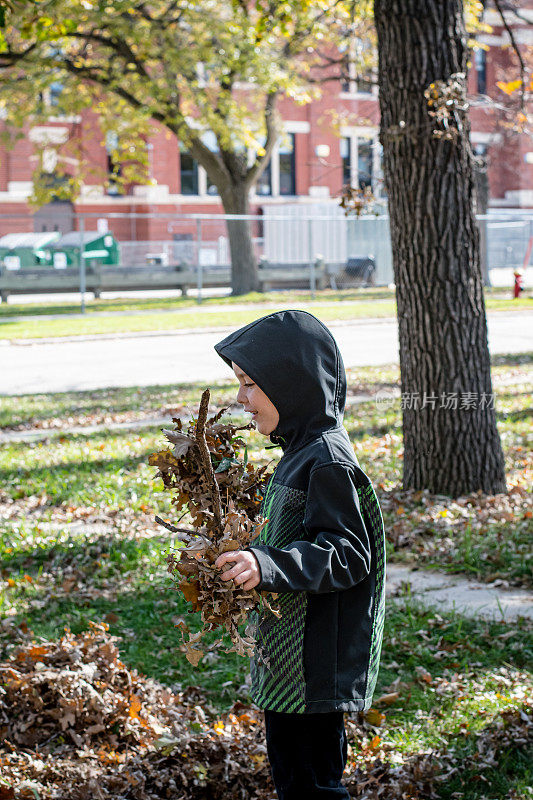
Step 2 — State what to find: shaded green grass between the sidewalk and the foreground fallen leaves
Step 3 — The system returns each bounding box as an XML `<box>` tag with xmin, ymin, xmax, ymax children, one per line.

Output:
<box><xmin>0</xmin><ymin>523</ymin><xmax>533</xmax><ymax>708</ymax></box>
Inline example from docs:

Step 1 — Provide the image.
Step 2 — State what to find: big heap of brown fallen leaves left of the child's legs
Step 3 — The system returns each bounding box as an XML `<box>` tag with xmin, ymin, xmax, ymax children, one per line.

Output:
<box><xmin>0</xmin><ymin>624</ymin><xmax>273</xmax><ymax>800</ymax></box>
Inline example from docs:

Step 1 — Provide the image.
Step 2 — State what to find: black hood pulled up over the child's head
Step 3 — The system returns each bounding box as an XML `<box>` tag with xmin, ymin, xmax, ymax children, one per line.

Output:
<box><xmin>215</xmin><ymin>310</ymin><xmax>346</xmax><ymax>451</ymax></box>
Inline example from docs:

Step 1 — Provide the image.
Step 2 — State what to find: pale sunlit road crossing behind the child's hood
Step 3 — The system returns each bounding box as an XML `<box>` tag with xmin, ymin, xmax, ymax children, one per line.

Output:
<box><xmin>0</xmin><ymin>311</ymin><xmax>533</xmax><ymax>395</ymax></box>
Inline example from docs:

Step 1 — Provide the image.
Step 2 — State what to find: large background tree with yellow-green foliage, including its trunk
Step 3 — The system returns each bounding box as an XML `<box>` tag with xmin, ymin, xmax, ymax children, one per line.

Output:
<box><xmin>0</xmin><ymin>0</ymin><xmax>370</xmax><ymax>294</ymax></box>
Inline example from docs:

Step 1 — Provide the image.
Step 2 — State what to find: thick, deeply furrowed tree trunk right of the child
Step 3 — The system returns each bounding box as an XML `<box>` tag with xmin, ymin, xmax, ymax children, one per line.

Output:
<box><xmin>374</xmin><ymin>0</ymin><xmax>506</xmax><ymax>497</ymax></box>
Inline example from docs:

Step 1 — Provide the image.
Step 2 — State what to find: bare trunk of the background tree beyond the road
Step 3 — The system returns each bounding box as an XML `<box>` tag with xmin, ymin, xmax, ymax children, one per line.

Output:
<box><xmin>220</xmin><ymin>182</ymin><xmax>259</xmax><ymax>295</ymax></box>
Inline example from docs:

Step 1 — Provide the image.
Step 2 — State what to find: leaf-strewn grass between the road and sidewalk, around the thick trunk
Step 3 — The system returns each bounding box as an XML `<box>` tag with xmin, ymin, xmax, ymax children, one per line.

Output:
<box><xmin>0</xmin><ymin>354</ymin><xmax>533</xmax><ymax>585</ymax></box>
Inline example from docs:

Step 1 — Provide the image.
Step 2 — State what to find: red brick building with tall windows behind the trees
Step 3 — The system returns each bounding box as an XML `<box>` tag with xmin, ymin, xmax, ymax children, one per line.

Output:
<box><xmin>0</xmin><ymin>0</ymin><xmax>533</xmax><ymax>241</ymax></box>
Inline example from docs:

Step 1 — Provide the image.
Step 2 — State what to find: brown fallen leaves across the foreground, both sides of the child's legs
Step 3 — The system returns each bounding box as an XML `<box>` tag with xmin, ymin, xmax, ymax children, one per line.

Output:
<box><xmin>0</xmin><ymin>623</ymin><xmax>533</xmax><ymax>800</ymax></box>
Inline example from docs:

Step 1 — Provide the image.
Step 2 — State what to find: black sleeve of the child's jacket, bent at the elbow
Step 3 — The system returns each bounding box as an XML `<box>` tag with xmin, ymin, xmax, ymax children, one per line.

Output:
<box><xmin>246</xmin><ymin>463</ymin><xmax>371</xmax><ymax>594</ymax></box>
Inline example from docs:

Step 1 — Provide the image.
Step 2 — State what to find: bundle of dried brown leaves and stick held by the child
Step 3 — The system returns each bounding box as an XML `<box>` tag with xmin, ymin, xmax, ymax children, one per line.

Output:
<box><xmin>149</xmin><ymin>389</ymin><xmax>279</xmax><ymax>665</ymax></box>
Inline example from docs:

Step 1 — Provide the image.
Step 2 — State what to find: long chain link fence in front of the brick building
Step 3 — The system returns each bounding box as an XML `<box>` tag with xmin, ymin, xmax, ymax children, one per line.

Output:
<box><xmin>0</xmin><ymin>204</ymin><xmax>533</xmax><ymax>308</ymax></box>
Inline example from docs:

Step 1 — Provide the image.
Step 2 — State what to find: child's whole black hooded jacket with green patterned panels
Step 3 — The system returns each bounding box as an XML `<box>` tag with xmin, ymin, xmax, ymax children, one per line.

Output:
<box><xmin>215</xmin><ymin>310</ymin><xmax>385</xmax><ymax>713</ymax></box>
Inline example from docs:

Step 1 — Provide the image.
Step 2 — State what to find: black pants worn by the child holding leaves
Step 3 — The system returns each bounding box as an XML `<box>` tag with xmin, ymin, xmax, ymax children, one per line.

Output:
<box><xmin>264</xmin><ymin>710</ymin><xmax>350</xmax><ymax>800</ymax></box>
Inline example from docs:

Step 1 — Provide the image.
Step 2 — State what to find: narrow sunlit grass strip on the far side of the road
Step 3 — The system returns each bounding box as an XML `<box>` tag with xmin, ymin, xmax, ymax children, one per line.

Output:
<box><xmin>0</xmin><ymin>288</ymin><xmax>533</xmax><ymax>339</ymax></box>
